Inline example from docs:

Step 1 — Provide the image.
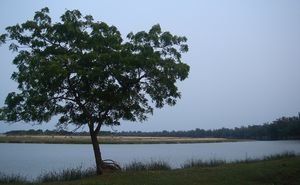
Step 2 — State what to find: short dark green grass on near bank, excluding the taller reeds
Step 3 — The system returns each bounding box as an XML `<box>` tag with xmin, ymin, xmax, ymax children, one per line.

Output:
<box><xmin>0</xmin><ymin>157</ymin><xmax>300</xmax><ymax>185</ymax></box>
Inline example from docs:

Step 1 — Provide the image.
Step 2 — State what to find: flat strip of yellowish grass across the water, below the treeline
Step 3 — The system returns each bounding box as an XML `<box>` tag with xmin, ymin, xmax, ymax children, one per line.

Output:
<box><xmin>0</xmin><ymin>135</ymin><xmax>240</xmax><ymax>144</ymax></box>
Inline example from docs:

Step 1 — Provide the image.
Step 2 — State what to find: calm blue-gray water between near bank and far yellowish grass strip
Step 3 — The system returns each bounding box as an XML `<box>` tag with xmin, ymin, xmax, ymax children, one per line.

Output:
<box><xmin>0</xmin><ymin>141</ymin><xmax>300</xmax><ymax>179</ymax></box>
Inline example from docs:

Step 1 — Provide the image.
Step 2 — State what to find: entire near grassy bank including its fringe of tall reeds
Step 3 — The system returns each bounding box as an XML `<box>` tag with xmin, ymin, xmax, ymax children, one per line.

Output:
<box><xmin>0</xmin><ymin>153</ymin><xmax>300</xmax><ymax>185</ymax></box>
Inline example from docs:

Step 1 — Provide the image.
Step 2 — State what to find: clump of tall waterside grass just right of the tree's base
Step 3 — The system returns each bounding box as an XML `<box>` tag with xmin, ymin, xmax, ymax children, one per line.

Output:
<box><xmin>124</xmin><ymin>161</ymin><xmax>171</xmax><ymax>171</ymax></box>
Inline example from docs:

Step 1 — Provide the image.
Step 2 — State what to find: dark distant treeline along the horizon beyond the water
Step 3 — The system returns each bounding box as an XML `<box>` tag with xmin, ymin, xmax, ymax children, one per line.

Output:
<box><xmin>5</xmin><ymin>117</ymin><xmax>300</xmax><ymax>140</ymax></box>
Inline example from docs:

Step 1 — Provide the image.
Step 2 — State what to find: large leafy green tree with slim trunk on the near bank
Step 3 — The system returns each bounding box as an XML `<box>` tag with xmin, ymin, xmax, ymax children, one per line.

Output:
<box><xmin>0</xmin><ymin>8</ymin><xmax>189</xmax><ymax>174</ymax></box>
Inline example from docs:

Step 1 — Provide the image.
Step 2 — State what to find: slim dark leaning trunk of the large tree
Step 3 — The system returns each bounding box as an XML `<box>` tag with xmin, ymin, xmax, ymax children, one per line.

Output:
<box><xmin>90</xmin><ymin>127</ymin><xmax>103</xmax><ymax>175</ymax></box>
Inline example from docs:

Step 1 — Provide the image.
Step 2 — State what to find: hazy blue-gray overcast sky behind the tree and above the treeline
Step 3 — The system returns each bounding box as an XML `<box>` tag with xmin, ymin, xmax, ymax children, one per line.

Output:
<box><xmin>0</xmin><ymin>0</ymin><xmax>300</xmax><ymax>133</ymax></box>
